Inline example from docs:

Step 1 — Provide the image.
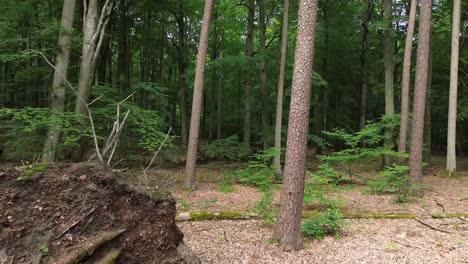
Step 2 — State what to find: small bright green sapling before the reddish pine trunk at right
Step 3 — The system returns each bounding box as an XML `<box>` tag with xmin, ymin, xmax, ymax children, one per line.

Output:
<box><xmin>367</xmin><ymin>165</ymin><xmax>422</xmax><ymax>203</ymax></box>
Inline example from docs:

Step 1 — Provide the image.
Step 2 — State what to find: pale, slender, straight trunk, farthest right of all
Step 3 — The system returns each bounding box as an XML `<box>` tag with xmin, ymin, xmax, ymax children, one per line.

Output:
<box><xmin>447</xmin><ymin>0</ymin><xmax>460</xmax><ymax>176</ymax></box>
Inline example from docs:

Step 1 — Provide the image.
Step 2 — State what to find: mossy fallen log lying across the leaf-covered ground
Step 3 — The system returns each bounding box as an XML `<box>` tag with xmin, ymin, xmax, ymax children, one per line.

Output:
<box><xmin>176</xmin><ymin>211</ymin><xmax>468</xmax><ymax>222</ymax></box>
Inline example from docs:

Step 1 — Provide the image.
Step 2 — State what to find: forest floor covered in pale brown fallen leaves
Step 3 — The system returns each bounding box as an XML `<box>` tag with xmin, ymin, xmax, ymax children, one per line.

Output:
<box><xmin>126</xmin><ymin>157</ymin><xmax>468</xmax><ymax>263</ymax></box>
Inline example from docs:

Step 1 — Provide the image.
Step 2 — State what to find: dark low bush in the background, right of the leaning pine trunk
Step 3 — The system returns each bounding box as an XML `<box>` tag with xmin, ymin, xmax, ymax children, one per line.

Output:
<box><xmin>202</xmin><ymin>135</ymin><xmax>251</xmax><ymax>161</ymax></box>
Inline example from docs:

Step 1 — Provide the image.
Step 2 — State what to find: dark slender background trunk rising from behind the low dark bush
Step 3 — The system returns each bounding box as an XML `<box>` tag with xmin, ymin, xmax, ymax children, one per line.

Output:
<box><xmin>244</xmin><ymin>0</ymin><xmax>255</xmax><ymax>145</ymax></box>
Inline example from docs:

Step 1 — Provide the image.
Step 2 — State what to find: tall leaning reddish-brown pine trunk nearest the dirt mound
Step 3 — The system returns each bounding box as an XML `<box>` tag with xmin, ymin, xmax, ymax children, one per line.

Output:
<box><xmin>184</xmin><ymin>0</ymin><xmax>214</xmax><ymax>190</ymax></box>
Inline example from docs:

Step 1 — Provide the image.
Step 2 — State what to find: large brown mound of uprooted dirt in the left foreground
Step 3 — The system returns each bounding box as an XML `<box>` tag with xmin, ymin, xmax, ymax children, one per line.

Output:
<box><xmin>0</xmin><ymin>164</ymin><xmax>200</xmax><ymax>264</ymax></box>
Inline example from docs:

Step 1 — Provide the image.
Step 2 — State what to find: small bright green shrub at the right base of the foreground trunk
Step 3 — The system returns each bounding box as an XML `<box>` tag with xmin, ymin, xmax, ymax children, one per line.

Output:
<box><xmin>301</xmin><ymin>208</ymin><xmax>346</xmax><ymax>240</ymax></box>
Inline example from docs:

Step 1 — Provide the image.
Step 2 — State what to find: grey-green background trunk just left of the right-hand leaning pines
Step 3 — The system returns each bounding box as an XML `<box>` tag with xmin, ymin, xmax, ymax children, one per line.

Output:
<box><xmin>384</xmin><ymin>0</ymin><xmax>395</xmax><ymax>166</ymax></box>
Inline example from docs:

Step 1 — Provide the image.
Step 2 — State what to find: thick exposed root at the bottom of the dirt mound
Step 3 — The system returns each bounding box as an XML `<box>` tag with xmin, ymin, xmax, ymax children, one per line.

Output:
<box><xmin>61</xmin><ymin>229</ymin><xmax>125</xmax><ymax>264</ymax></box>
